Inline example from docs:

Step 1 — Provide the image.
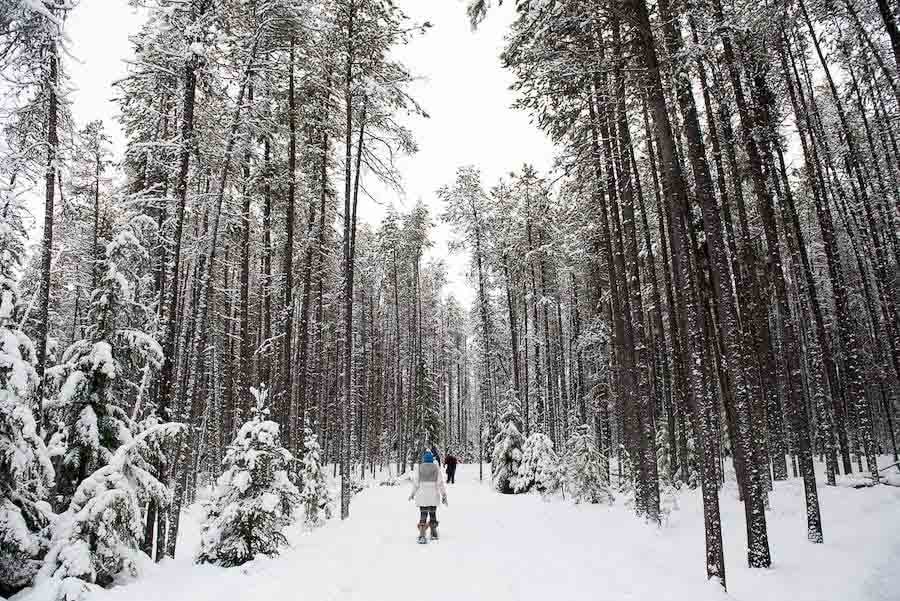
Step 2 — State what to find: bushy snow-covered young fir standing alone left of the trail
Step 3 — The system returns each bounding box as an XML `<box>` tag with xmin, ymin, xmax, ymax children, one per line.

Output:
<box><xmin>197</xmin><ymin>389</ymin><xmax>301</xmax><ymax>567</ymax></box>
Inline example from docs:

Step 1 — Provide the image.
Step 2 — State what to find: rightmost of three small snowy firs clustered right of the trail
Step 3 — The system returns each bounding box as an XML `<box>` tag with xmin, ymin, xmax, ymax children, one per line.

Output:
<box><xmin>561</xmin><ymin>426</ymin><xmax>613</xmax><ymax>503</ymax></box>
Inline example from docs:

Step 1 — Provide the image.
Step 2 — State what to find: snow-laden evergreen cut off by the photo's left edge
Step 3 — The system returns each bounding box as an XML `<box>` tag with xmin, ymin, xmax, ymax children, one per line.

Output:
<box><xmin>0</xmin><ymin>205</ymin><xmax>53</xmax><ymax>596</ymax></box>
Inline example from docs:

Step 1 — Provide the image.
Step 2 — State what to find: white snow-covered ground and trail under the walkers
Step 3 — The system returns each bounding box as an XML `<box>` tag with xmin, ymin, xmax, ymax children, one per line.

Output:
<box><xmin>92</xmin><ymin>458</ymin><xmax>900</xmax><ymax>601</ymax></box>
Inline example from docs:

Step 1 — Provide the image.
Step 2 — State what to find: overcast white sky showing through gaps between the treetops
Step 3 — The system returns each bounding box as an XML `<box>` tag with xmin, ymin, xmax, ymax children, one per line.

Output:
<box><xmin>67</xmin><ymin>0</ymin><xmax>553</xmax><ymax>304</ymax></box>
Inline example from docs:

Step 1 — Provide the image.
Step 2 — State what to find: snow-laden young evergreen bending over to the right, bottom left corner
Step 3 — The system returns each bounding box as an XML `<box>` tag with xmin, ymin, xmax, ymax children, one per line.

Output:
<box><xmin>30</xmin><ymin>424</ymin><xmax>184</xmax><ymax>601</ymax></box>
